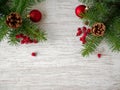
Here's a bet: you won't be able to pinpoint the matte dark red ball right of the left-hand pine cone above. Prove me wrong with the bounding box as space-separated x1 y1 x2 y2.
29 9 42 22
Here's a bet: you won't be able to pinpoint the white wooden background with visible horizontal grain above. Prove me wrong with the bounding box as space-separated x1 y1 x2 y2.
0 0 120 90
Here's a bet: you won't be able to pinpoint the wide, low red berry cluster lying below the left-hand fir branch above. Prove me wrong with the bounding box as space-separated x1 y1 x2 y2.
16 34 38 44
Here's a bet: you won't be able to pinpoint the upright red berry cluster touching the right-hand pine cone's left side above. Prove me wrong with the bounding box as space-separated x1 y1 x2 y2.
76 26 91 44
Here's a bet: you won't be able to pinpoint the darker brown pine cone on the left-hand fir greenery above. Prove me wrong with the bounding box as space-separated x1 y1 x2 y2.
6 12 22 28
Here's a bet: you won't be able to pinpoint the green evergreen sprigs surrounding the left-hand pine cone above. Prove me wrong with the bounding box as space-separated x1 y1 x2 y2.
0 0 46 45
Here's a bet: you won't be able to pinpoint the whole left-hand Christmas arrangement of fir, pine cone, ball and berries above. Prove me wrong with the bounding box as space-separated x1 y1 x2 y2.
0 0 46 45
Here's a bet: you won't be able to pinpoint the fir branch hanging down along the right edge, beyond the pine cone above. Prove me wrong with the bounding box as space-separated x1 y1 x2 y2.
106 17 120 51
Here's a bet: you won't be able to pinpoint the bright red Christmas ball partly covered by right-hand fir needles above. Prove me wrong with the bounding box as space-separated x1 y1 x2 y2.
75 5 86 18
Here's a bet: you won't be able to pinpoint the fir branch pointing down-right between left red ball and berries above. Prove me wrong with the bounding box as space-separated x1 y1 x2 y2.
20 19 46 41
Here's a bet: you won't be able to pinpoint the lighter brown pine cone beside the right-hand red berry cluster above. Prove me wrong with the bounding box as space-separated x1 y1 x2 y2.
91 23 106 36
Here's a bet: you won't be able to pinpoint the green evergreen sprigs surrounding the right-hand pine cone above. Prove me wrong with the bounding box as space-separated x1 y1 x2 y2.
79 0 120 56
